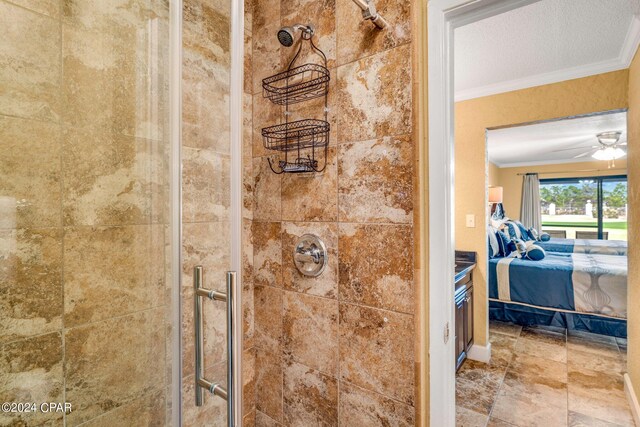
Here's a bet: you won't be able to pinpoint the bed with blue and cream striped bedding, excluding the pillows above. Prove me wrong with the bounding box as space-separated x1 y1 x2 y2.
489 252 627 337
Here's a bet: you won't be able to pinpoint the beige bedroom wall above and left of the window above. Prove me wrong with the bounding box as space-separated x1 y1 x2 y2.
498 159 627 219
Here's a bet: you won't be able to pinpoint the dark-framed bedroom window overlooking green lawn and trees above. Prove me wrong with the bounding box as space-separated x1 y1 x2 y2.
540 176 627 240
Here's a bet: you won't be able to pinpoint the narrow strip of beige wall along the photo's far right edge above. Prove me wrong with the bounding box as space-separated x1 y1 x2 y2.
627 46 640 412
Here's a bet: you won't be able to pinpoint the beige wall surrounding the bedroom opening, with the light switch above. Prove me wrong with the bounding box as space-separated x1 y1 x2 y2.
455 70 629 345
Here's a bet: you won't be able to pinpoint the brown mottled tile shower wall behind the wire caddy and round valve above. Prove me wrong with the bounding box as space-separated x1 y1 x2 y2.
245 0 416 426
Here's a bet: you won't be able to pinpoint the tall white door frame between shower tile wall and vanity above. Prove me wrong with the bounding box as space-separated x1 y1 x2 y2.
427 0 539 427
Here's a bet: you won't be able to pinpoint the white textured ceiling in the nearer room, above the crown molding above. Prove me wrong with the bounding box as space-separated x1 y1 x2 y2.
454 0 640 100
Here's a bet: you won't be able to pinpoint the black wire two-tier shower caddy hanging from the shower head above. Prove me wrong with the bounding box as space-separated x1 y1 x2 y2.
262 32 331 174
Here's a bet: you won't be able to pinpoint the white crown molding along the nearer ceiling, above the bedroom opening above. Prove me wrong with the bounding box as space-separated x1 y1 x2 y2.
455 15 640 102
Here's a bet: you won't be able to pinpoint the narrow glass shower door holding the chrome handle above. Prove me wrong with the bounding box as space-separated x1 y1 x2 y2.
181 0 243 426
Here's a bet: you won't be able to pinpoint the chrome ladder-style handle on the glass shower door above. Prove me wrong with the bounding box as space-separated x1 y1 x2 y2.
193 265 236 427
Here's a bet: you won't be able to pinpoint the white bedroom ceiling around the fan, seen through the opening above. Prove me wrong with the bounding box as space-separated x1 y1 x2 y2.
487 112 627 167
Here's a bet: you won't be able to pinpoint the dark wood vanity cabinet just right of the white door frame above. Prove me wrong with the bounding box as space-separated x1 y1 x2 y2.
455 271 473 370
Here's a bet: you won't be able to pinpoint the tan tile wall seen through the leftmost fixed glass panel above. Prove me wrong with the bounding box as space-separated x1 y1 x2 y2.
0 0 170 426
